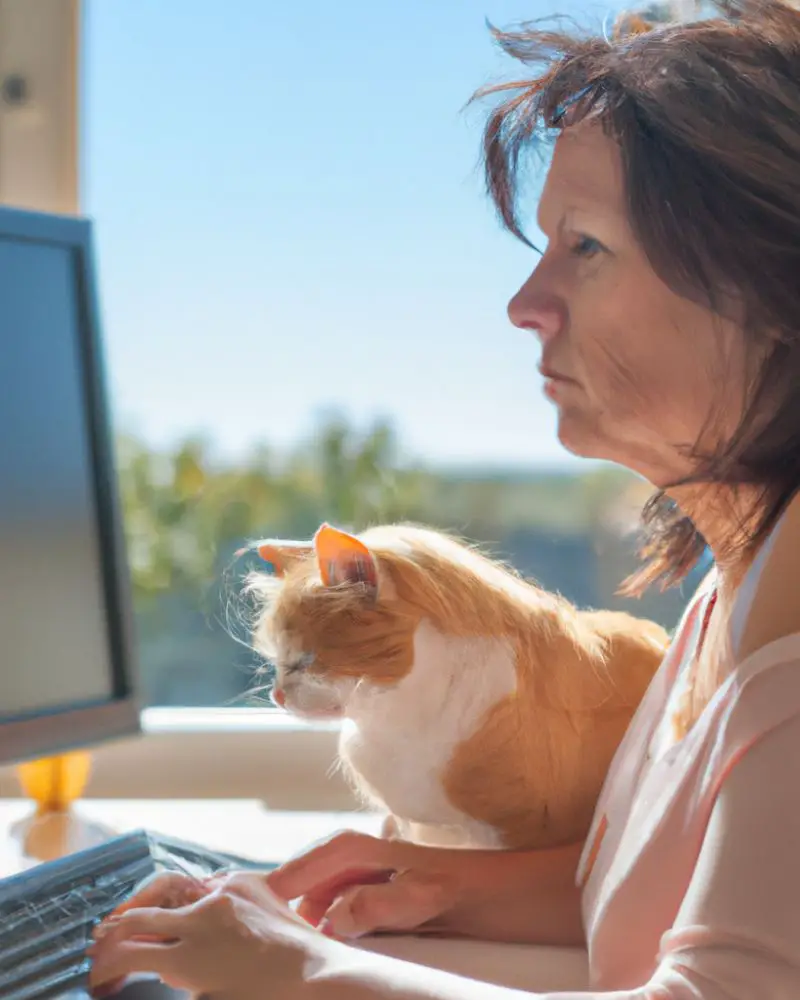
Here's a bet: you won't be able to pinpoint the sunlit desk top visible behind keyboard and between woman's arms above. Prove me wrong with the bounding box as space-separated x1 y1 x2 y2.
0 799 588 991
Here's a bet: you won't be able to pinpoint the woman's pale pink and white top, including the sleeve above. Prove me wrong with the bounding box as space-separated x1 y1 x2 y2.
558 500 800 1000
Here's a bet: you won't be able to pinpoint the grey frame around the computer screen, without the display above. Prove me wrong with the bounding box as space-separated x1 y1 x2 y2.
0 206 141 765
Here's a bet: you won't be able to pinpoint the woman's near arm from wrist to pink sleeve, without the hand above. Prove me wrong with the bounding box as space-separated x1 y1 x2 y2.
314 712 800 1000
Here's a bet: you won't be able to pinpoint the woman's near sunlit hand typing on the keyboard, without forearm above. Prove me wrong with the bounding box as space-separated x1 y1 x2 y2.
89 873 328 1000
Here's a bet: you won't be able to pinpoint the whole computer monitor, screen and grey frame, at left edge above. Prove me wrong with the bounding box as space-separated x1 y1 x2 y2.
0 208 139 763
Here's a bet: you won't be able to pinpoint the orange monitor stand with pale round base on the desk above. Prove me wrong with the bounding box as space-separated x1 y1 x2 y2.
9 751 117 862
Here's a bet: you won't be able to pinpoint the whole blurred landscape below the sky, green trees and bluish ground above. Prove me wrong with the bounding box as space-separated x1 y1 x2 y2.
112 416 700 705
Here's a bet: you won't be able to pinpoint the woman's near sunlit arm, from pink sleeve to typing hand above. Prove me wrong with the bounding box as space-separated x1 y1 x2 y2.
91 712 800 1000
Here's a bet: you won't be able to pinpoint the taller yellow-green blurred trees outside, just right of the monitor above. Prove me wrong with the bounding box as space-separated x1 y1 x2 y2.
117 419 422 598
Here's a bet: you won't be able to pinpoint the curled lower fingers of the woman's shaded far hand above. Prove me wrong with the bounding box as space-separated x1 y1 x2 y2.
319 872 453 940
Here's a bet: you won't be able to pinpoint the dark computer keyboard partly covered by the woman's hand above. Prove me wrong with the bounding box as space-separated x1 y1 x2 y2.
0 830 275 1000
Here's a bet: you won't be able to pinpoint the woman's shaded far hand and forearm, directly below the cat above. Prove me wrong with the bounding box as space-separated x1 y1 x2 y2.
266 832 585 945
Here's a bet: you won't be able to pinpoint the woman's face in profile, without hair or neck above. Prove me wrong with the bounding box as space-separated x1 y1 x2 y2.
509 122 746 485
